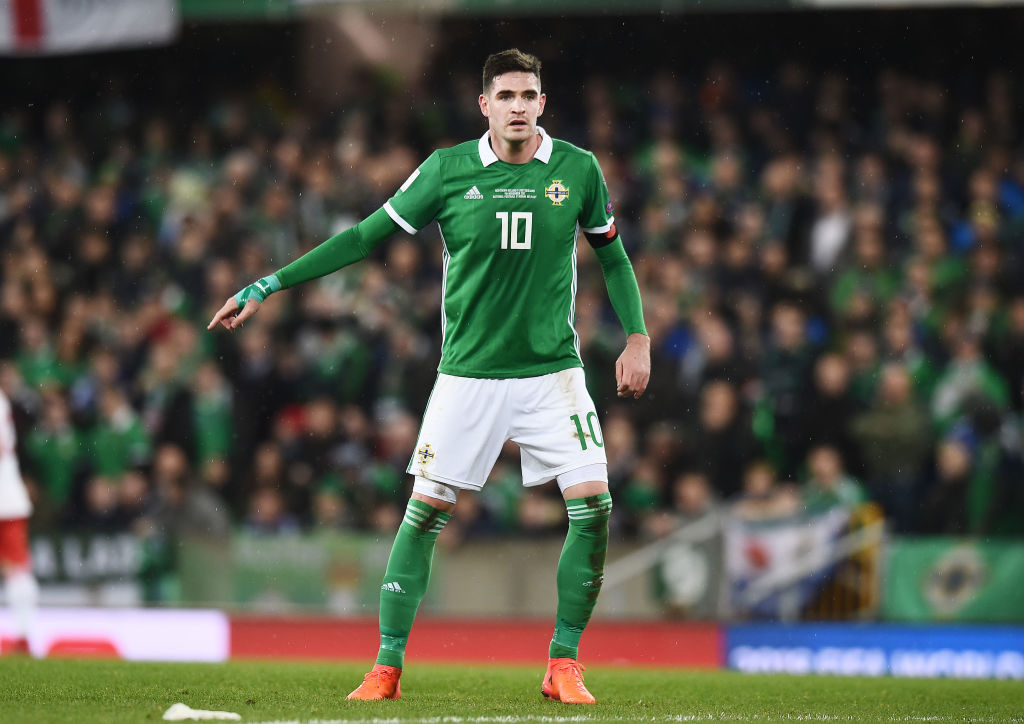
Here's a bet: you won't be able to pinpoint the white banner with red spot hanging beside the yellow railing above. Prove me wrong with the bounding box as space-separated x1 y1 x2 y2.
725 508 850 619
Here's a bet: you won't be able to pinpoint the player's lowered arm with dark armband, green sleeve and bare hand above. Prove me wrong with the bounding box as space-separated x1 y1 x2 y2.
587 235 650 398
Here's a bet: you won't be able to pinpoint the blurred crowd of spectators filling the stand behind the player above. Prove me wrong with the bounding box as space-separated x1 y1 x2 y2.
0 52 1024 548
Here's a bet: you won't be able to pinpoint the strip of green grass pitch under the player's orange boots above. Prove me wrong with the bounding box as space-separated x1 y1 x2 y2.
0 658 1024 724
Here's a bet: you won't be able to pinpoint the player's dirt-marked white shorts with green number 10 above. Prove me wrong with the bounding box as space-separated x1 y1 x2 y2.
409 368 608 491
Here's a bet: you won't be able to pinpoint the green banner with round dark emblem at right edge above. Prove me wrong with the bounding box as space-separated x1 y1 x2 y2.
882 538 1024 622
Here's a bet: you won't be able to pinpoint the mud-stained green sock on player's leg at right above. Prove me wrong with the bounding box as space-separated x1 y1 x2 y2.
548 493 611 658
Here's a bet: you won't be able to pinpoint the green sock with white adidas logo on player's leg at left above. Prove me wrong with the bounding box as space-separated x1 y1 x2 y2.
377 500 452 669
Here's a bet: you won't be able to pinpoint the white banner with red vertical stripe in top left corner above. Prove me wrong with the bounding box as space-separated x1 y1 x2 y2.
0 0 179 55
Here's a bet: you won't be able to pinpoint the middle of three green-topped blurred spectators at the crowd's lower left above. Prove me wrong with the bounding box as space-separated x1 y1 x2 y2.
89 387 152 477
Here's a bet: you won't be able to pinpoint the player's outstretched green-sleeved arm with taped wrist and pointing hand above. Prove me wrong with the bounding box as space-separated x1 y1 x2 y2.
207 209 398 332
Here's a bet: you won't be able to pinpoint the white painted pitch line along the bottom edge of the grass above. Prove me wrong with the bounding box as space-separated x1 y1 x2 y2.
241 712 1024 724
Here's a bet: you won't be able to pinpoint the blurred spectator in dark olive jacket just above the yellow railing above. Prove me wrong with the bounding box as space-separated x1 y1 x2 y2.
851 363 932 533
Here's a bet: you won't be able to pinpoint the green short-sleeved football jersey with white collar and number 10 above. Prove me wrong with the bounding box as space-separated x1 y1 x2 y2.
384 128 613 378
